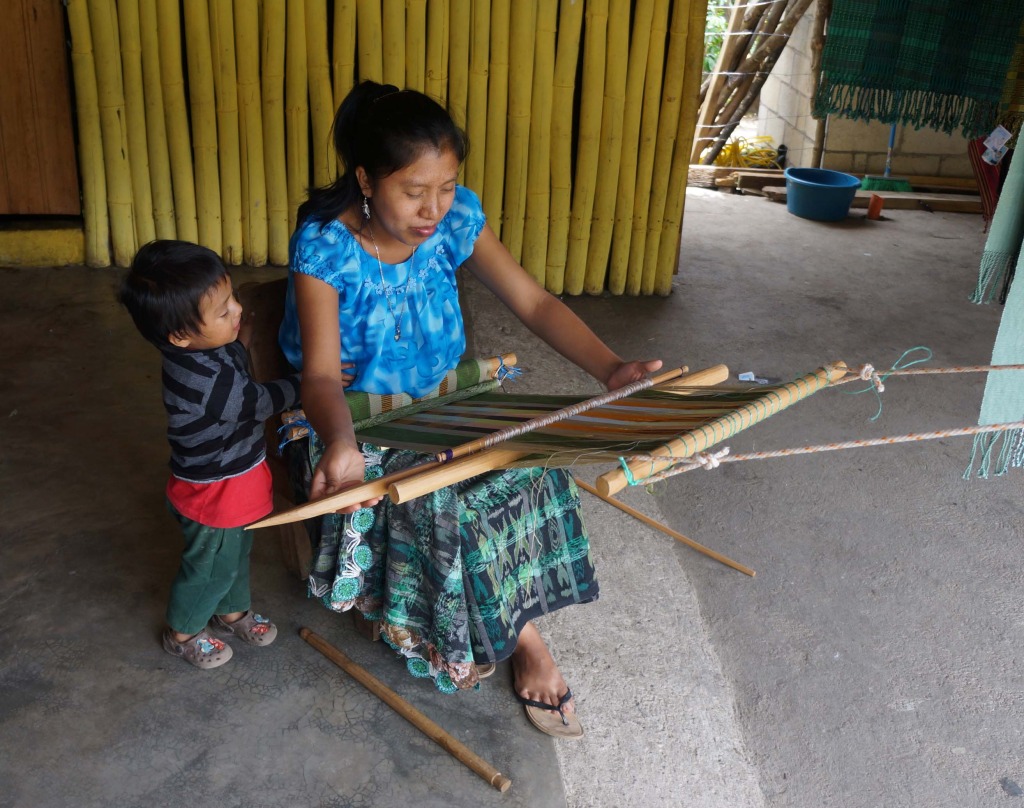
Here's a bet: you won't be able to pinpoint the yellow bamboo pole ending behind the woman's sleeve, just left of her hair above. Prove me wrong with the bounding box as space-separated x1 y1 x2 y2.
285 0 309 230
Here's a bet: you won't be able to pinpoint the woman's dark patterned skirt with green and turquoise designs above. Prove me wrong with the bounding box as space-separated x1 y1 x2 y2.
289 434 598 692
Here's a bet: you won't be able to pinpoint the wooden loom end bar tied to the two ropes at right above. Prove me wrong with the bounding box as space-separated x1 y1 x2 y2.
597 363 847 497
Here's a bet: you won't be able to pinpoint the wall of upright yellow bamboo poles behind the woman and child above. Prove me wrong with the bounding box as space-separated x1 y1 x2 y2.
67 0 707 295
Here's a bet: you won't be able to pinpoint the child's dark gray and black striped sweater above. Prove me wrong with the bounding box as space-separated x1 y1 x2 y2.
163 341 299 482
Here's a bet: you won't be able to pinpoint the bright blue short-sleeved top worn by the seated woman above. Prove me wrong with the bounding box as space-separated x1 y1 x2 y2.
279 185 486 396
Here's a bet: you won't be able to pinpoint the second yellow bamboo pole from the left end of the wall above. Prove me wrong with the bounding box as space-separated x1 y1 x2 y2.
89 0 137 266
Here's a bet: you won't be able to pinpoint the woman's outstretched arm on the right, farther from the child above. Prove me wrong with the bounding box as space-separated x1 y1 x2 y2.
466 224 662 390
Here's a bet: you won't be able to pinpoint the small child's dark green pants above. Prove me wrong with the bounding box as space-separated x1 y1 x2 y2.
167 503 253 634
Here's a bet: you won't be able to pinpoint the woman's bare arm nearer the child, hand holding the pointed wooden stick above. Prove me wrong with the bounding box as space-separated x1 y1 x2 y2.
294 273 380 513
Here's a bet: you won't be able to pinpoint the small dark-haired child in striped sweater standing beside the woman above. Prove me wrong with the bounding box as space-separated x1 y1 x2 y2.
119 241 299 668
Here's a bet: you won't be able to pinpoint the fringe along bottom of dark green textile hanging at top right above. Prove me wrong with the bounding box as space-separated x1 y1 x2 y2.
814 83 999 137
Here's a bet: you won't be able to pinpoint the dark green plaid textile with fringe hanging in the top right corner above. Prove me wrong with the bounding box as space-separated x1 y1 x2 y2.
814 0 1024 137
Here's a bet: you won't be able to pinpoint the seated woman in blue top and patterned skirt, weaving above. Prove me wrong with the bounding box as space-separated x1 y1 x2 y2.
281 82 662 736
